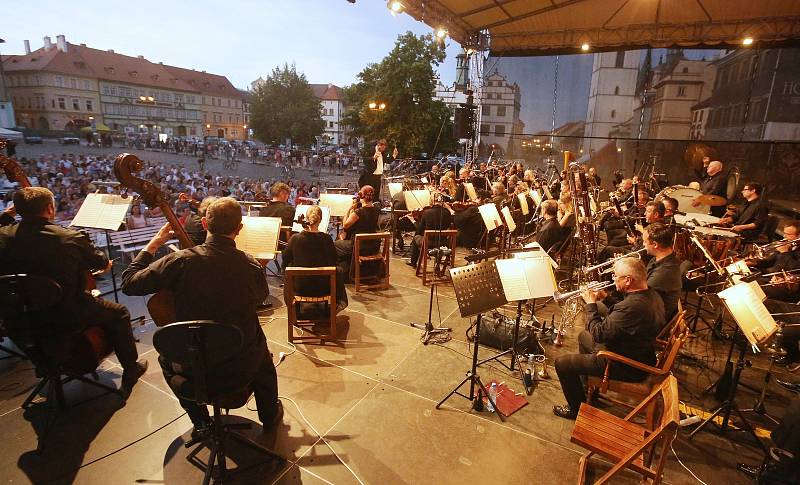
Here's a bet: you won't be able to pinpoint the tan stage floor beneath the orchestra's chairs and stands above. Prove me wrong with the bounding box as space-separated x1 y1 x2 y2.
0 248 797 484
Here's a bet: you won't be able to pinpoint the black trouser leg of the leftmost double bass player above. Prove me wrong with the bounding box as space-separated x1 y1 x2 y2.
70 298 139 369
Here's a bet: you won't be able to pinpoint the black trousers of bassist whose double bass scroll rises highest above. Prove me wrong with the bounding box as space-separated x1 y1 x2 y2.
158 356 278 427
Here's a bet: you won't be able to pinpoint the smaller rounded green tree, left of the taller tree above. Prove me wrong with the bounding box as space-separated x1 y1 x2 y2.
250 64 325 145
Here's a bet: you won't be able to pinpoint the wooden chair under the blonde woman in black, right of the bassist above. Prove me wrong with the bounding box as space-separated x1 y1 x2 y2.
283 266 336 343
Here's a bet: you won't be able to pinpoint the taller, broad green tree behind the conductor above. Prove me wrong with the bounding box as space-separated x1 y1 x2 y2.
343 32 457 157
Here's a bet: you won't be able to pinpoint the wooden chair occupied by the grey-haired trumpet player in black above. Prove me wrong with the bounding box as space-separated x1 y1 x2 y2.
587 313 689 407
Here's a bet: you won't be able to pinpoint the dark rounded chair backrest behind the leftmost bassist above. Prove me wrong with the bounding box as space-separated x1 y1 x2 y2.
0 274 61 318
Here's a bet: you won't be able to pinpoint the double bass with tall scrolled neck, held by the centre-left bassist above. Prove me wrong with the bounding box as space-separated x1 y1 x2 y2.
114 153 194 327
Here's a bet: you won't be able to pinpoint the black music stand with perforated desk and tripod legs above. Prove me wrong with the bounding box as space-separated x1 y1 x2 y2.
436 261 506 421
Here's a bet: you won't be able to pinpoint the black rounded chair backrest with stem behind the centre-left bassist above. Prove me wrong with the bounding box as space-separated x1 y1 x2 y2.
153 320 242 403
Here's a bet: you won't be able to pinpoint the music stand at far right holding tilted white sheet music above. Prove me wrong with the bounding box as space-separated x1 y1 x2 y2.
689 282 778 452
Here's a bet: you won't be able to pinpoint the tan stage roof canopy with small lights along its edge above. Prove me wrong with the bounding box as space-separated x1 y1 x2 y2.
398 0 800 56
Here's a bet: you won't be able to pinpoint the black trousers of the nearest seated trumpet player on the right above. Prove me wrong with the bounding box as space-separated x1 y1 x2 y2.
554 330 644 413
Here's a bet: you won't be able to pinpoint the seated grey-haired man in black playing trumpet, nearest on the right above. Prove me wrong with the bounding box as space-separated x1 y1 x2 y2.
553 258 664 419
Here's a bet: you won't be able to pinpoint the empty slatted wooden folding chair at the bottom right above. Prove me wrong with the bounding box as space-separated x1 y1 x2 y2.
570 376 680 484
